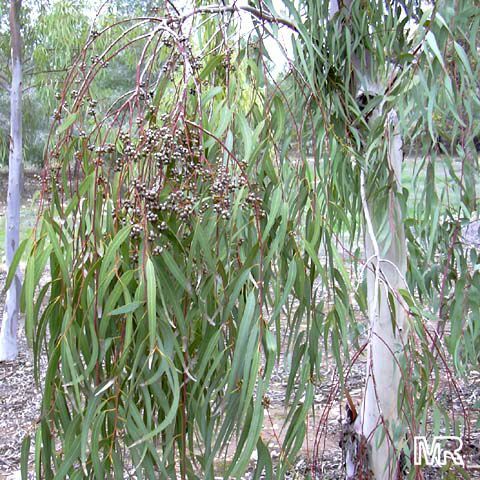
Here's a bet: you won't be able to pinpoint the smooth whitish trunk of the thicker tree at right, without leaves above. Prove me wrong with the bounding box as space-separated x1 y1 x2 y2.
357 112 407 480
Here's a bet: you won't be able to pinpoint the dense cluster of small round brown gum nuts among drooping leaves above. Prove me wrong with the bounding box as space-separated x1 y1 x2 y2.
109 125 261 261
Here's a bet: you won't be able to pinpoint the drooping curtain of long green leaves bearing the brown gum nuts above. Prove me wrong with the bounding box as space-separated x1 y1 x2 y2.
15 5 304 478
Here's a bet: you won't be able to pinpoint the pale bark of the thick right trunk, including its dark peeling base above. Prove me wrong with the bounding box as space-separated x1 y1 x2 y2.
328 0 407 480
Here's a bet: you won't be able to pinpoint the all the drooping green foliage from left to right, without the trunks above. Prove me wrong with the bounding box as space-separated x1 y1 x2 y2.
13 0 480 479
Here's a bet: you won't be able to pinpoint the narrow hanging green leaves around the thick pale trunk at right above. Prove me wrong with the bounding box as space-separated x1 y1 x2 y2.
271 1 480 478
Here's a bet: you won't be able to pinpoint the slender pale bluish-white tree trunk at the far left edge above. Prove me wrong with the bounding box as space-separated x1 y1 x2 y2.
0 0 23 361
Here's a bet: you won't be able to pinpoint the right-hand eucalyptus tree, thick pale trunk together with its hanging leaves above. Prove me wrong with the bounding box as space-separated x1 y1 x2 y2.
269 1 479 479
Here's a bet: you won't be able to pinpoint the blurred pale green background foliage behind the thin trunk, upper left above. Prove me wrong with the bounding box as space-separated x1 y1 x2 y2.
0 0 160 168
